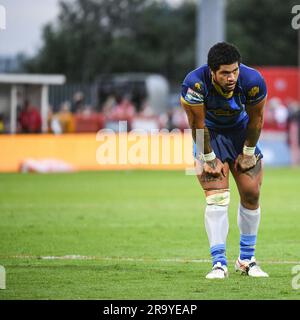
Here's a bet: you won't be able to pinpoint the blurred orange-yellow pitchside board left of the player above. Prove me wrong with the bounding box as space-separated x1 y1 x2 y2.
0 133 193 172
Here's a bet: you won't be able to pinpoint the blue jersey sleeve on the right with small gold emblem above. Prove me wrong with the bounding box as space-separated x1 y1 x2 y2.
246 70 267 106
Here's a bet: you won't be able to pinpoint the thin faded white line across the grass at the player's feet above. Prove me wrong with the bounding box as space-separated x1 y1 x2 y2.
0 255 300 265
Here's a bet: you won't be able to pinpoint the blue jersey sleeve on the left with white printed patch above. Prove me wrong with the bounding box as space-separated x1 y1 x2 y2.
181 75 204 106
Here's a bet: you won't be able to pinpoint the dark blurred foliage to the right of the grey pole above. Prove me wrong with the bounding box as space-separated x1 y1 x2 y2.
226 0 299 66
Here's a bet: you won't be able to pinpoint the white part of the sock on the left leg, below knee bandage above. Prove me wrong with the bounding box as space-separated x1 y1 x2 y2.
205 205 229 247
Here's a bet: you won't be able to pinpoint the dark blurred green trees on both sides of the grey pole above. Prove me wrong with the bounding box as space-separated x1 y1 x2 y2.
24 0 297 83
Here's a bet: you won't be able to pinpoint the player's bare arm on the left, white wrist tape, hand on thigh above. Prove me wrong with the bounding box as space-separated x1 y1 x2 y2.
180 97 225 177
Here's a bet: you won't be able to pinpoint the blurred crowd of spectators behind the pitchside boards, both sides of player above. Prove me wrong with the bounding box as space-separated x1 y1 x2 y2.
0 92 300 141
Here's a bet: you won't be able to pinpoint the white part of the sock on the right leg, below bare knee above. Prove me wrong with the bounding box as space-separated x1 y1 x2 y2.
238 204 260 235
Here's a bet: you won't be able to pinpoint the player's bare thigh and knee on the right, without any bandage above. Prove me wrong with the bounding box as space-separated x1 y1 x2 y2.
230 160 263 205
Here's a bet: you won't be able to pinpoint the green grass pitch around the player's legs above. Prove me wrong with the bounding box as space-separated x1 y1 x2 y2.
0 168 300 300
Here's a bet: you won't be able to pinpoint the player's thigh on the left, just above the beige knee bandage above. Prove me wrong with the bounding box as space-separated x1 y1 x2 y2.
195 160 229 196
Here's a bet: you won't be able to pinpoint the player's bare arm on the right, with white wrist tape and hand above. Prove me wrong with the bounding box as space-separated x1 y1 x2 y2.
237 98 266 172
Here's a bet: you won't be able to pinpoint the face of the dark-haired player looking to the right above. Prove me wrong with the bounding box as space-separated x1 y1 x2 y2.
212 62 240 91
